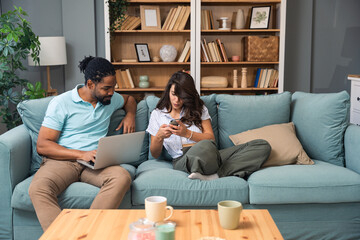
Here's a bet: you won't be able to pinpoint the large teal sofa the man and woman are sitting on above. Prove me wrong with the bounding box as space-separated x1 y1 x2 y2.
0 91 360 240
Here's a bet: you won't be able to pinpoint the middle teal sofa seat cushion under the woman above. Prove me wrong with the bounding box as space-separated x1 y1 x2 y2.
131 160 249 207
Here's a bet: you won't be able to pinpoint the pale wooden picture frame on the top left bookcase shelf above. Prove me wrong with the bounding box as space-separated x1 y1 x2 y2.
140 5 161 30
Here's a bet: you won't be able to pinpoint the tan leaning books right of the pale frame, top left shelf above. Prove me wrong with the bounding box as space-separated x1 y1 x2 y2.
162 6 190 30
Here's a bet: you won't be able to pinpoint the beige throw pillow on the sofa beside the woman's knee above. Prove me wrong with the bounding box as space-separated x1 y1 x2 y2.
229 122 314 167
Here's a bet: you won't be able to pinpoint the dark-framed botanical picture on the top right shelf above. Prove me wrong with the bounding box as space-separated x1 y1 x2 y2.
250 6 271 29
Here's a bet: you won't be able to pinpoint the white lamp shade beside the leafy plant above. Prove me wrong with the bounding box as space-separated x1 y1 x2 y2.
28 37 67 66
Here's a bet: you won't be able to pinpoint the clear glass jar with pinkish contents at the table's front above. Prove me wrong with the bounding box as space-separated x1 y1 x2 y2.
128 218 155 240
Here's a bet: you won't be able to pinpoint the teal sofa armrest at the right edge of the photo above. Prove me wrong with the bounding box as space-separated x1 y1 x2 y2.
344 124 360 174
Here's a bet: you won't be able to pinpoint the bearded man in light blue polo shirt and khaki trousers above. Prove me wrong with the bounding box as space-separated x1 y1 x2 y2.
29 57 136 231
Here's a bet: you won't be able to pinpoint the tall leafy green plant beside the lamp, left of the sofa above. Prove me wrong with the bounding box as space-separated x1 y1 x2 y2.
0 6 45 129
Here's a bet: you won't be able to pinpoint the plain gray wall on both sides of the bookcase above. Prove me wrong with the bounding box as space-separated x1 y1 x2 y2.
0 0 360 133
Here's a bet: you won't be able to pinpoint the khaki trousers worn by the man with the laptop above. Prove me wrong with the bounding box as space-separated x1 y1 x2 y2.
29 158 131 231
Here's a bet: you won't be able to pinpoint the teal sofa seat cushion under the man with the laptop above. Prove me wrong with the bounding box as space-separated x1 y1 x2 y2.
11 164 135 211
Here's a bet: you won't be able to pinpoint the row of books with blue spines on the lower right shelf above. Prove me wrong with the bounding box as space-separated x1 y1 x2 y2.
254 68 279 88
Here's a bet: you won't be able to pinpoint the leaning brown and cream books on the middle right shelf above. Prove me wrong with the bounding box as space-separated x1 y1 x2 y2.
201 38 229 62
